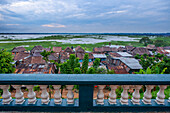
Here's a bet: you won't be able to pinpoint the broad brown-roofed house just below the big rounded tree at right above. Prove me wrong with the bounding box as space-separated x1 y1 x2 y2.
131 47 150 56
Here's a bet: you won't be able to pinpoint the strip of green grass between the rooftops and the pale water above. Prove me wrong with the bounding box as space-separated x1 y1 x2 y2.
0 41 143 51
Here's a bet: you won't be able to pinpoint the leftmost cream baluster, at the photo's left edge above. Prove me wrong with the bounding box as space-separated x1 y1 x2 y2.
1 85 12 104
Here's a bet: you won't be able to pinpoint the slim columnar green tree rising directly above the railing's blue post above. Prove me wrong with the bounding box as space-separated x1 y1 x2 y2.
81 53 89 73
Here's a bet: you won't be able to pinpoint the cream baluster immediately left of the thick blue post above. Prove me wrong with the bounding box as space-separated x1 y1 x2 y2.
66 85 74 104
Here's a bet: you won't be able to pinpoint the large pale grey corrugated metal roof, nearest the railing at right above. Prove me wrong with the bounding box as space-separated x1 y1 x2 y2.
119 57 142 69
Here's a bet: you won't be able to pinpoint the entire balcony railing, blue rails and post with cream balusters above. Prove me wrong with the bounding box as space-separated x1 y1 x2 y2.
0 74 170 112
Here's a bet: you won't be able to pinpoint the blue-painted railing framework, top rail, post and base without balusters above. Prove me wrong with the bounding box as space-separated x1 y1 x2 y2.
0 74 170 112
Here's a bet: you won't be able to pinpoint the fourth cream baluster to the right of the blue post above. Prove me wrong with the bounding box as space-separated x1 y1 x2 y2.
132 85 142 104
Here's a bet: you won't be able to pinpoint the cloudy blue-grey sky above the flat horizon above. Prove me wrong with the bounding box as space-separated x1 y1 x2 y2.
0 0 170 33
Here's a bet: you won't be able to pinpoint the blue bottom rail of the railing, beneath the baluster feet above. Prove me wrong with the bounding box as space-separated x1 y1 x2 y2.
0 99 170 112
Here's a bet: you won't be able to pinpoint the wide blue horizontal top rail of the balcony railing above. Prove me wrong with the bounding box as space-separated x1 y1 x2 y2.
0 74 170 85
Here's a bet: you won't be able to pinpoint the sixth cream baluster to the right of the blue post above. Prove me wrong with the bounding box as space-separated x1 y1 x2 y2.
155 85 167 104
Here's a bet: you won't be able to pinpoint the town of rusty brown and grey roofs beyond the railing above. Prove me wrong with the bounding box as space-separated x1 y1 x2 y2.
11 44 170 74
